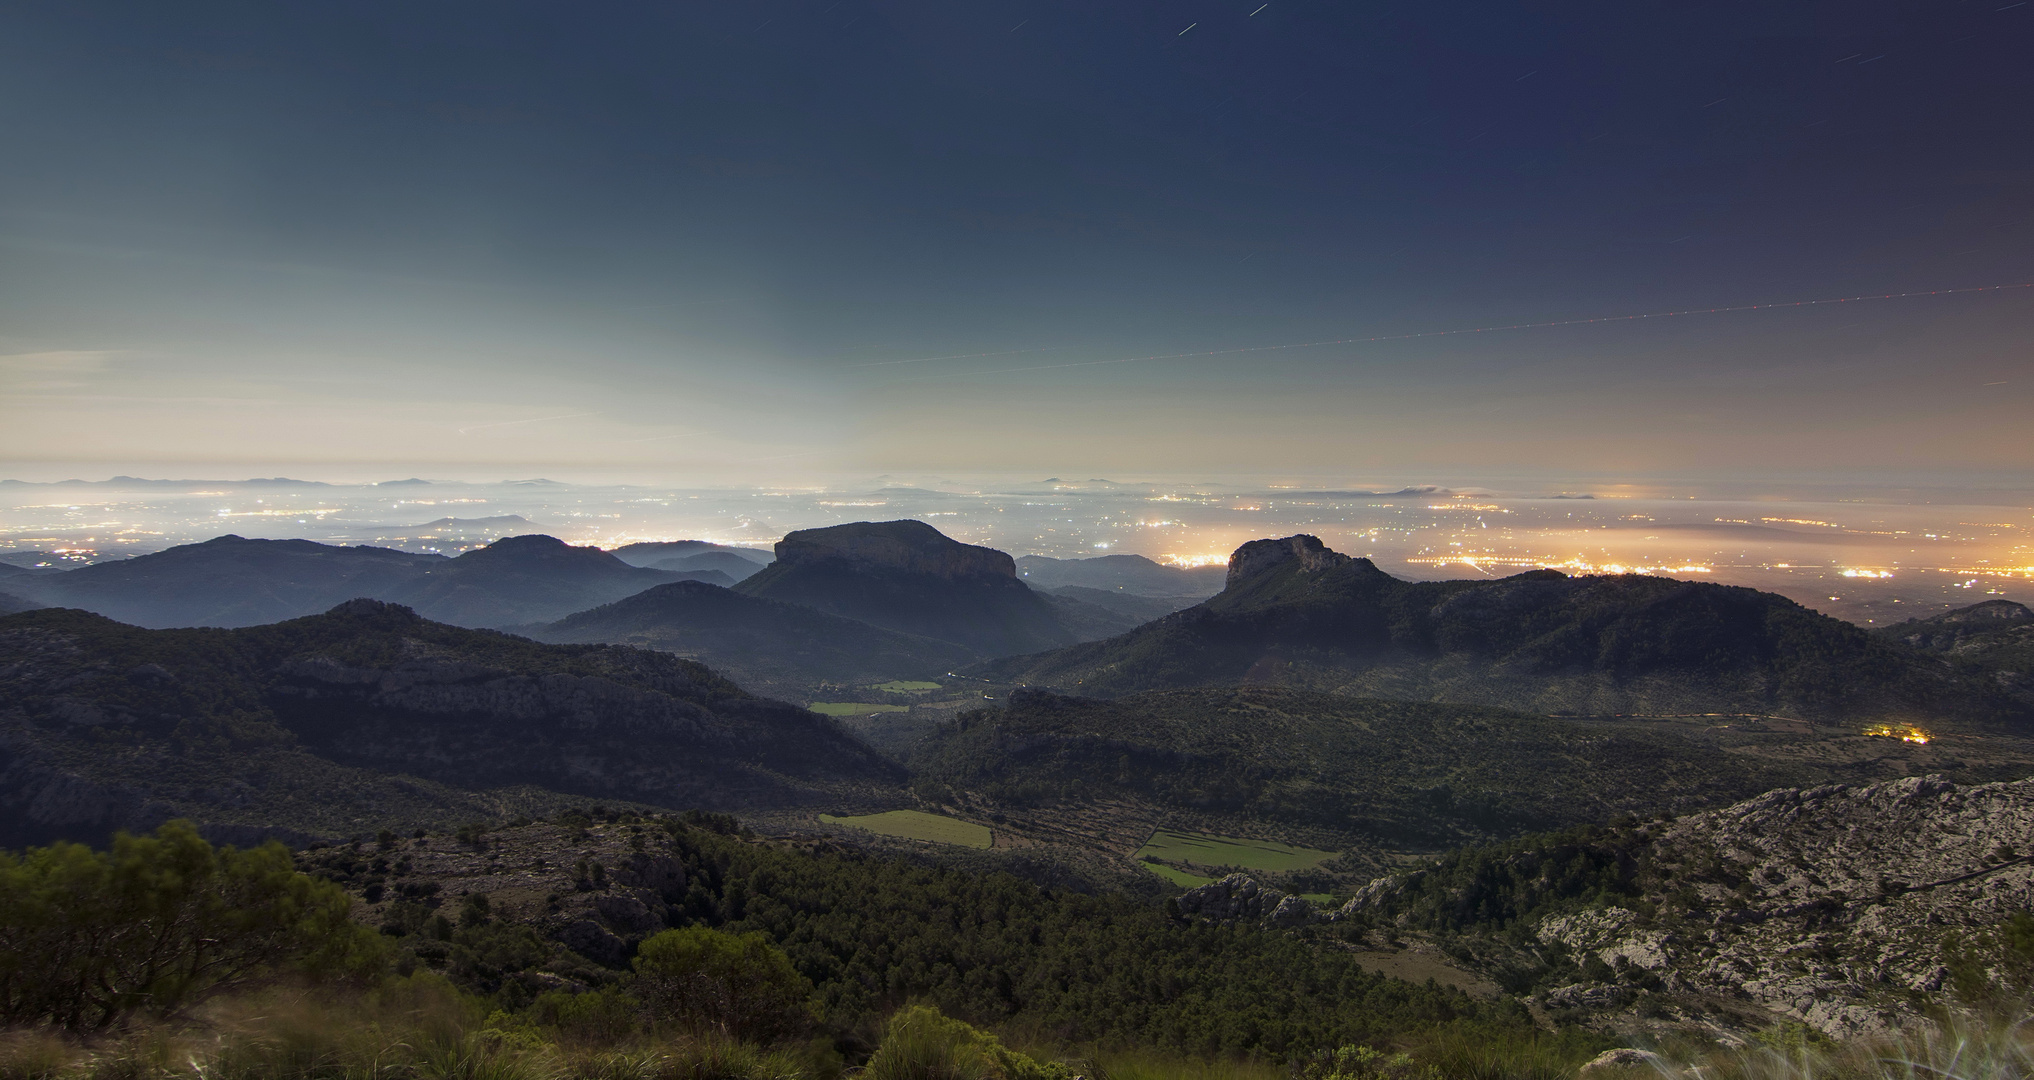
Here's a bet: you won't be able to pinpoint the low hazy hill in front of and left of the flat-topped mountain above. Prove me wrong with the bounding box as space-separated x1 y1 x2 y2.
531 582 974 694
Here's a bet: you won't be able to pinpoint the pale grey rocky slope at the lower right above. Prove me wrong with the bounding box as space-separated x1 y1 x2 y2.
1340 777 2034 1037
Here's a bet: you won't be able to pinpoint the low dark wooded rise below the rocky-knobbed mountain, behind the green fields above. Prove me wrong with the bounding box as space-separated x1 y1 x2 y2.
911 687 2026 850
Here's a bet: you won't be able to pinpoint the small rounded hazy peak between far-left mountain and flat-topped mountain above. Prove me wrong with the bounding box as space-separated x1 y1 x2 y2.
388 537 677 626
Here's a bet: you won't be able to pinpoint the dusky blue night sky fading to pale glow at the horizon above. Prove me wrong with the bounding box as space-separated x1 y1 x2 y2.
0 0 2034 482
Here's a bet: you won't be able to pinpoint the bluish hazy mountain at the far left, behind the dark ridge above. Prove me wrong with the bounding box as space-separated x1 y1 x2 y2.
8 535 439 626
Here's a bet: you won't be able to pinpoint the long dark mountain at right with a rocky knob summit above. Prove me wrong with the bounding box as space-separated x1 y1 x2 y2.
976 535 2028 722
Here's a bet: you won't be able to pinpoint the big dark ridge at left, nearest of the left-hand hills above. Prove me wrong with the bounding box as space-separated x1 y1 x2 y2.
0 600 901 846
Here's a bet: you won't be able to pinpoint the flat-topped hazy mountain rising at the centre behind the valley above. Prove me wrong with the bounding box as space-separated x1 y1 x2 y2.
734 521 1074 657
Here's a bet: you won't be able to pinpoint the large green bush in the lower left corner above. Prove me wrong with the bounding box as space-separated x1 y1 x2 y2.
0 822 382 1029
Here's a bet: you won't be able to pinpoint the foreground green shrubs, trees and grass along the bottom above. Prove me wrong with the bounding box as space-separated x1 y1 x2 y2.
15 814 2034 1080
